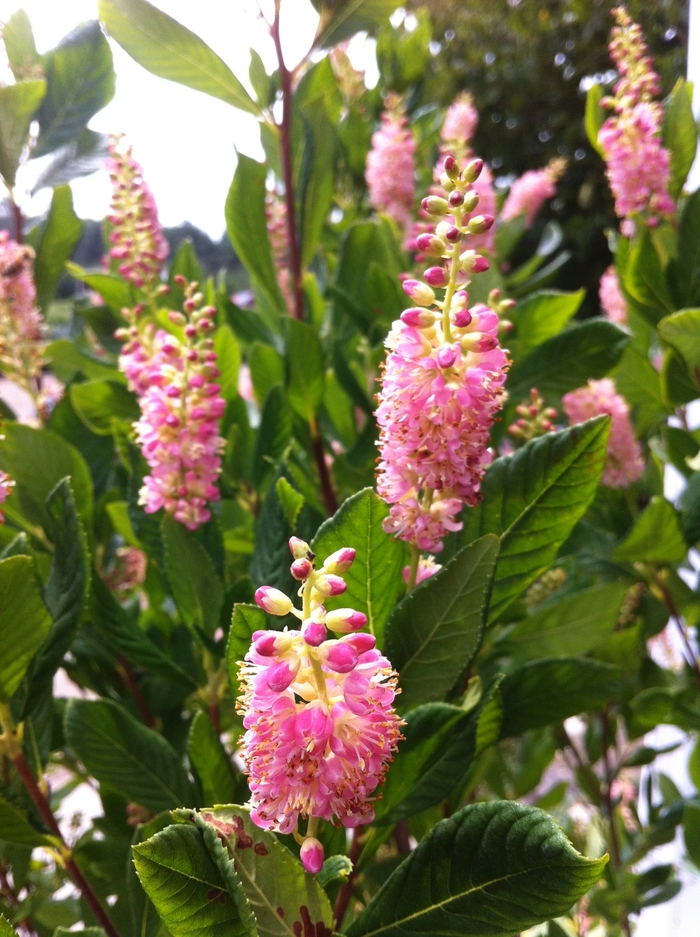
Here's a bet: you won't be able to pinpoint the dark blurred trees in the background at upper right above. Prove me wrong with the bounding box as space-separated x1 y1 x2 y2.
400 0 688 314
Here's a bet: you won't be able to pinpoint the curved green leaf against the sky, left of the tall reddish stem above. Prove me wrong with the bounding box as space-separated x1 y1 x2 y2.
226 153 285 311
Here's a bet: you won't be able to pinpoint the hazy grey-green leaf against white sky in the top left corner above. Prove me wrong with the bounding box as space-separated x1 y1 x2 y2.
32 20 115 157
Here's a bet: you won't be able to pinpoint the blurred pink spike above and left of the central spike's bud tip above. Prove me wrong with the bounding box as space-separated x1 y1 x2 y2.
365 96 416 229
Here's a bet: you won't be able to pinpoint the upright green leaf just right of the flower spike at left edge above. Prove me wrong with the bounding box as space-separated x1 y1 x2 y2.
34 185 83 310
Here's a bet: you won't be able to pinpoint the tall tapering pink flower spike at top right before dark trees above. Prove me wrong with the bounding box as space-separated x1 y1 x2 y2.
598 7 675 234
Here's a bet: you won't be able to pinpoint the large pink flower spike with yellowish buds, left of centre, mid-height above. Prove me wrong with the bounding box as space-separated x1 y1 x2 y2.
117 277 226 530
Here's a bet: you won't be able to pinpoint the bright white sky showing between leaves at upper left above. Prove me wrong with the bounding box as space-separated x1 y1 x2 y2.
0 0 328 238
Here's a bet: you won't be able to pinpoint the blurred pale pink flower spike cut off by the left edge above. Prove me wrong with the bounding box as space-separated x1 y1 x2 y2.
0 231 46 399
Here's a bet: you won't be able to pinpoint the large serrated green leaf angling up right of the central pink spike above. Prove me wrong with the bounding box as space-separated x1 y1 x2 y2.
461 417 609 621
